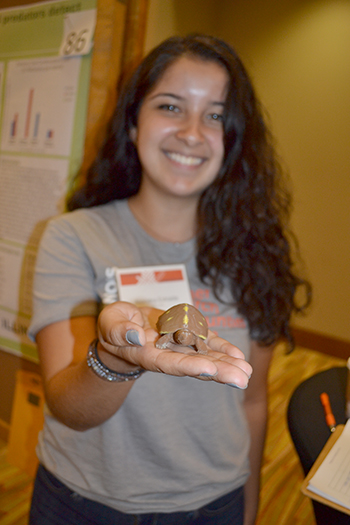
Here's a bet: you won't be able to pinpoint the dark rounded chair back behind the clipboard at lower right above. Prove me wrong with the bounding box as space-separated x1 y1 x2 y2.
287 367 350 525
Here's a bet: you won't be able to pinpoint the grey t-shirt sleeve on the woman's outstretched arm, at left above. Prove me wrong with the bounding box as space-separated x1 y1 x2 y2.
28 216 99 340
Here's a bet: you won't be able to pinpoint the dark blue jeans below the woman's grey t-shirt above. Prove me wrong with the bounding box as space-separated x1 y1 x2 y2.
29 465 244 525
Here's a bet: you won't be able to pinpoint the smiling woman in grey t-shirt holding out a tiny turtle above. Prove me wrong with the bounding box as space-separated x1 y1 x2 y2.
30 35 307 525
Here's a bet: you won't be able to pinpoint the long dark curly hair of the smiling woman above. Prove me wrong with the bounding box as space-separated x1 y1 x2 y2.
67 34 310 345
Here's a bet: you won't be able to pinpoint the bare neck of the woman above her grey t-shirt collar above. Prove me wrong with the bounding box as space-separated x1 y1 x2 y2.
128 194 197 243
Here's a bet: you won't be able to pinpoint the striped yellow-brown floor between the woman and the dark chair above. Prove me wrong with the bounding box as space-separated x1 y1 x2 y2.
257 346 346 525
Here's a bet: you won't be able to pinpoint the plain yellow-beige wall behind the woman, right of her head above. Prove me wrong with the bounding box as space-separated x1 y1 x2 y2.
146 0 350 341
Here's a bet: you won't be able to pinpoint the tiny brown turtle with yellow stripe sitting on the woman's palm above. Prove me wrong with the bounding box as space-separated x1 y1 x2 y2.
156 303 209 354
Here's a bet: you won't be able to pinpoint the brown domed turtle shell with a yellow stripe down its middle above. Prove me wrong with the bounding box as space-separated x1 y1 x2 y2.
157 303 208 340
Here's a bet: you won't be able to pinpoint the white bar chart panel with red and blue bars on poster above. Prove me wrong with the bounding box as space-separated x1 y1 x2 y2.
1 57 81 156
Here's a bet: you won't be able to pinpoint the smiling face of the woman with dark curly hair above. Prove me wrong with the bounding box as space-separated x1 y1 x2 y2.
131 57 228 198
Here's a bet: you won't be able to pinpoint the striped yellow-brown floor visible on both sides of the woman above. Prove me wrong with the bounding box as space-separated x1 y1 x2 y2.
0 346 345 525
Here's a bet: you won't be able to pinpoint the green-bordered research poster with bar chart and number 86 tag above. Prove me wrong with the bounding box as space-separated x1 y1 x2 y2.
0 0 96 361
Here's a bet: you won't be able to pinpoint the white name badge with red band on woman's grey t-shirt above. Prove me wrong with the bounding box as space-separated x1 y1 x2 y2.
116 264 192 310
